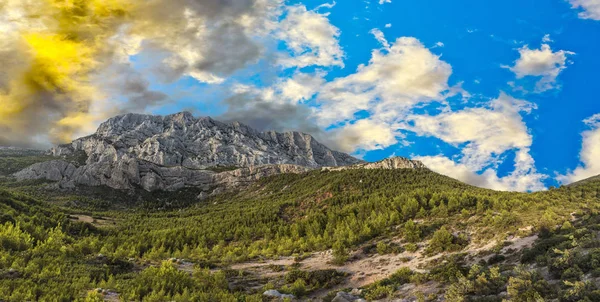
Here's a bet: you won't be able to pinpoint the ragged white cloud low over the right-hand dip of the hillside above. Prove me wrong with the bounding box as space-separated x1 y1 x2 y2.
407 93 546 191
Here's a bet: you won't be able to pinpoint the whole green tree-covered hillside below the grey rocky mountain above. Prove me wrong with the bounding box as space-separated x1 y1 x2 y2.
0 169 600 301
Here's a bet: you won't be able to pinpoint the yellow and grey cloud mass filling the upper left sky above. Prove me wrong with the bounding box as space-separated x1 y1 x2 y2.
0 0 281 145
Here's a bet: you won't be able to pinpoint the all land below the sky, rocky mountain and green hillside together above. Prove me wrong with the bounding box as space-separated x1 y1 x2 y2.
0 113 600 302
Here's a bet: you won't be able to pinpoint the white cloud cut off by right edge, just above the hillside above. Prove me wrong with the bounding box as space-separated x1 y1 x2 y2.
558 114 600 183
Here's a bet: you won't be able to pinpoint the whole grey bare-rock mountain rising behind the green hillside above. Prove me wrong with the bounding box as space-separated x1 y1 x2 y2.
15 113 362 191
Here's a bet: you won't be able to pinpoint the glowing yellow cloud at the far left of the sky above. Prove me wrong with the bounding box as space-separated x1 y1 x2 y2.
0 0 135 143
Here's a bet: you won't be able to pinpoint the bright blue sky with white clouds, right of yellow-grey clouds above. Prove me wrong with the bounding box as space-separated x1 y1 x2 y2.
125 0 600 191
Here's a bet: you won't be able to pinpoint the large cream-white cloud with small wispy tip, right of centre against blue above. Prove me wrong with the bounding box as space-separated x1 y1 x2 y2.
318 30 452 126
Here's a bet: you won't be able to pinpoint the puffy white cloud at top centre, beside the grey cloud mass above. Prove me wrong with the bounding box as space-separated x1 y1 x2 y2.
276 5 344 67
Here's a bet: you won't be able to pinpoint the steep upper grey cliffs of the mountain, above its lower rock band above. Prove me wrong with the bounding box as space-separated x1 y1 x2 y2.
52 112 362 169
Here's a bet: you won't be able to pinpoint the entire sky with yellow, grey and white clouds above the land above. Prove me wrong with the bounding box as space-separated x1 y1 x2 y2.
0 0 600 191
